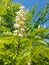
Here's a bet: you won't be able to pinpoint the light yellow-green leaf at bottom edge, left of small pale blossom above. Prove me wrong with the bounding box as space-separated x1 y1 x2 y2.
16 51 31 65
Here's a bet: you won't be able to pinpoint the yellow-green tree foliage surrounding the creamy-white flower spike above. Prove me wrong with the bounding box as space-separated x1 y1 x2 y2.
0 0 49 65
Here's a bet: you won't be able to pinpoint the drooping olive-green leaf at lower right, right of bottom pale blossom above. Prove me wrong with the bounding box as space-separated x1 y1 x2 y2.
31 46 42 63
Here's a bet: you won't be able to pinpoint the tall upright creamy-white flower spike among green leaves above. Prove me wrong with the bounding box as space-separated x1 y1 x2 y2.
14 6 26 36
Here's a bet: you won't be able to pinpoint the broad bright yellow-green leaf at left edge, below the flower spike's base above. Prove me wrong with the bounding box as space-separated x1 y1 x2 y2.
0 34 17 44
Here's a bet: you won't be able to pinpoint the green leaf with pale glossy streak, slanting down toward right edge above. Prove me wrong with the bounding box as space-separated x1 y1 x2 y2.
32 35 48 46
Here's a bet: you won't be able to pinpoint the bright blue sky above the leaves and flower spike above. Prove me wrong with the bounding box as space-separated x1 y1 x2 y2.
13 0 49 26
